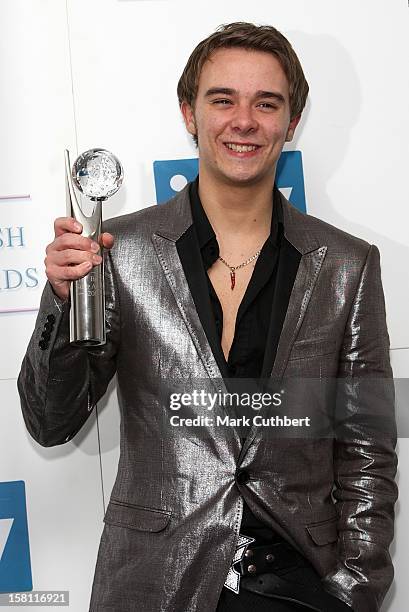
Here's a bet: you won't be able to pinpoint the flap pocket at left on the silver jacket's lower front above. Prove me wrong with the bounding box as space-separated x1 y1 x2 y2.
104 499 172 532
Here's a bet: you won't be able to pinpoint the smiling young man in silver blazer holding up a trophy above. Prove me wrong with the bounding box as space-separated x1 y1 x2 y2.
19 23 396 612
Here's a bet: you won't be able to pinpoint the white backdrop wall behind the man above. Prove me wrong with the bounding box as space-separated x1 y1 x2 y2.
0 0 409 612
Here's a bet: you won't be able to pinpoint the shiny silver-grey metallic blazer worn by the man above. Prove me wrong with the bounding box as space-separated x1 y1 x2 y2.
18 187 397 612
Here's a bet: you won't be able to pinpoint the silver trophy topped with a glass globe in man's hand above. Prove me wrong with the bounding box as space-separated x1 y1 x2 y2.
65 149 123 346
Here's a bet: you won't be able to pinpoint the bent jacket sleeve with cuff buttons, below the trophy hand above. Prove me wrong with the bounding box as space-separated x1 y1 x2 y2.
17 252 120 446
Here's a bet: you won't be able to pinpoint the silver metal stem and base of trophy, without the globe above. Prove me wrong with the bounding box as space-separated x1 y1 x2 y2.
65 151 106 346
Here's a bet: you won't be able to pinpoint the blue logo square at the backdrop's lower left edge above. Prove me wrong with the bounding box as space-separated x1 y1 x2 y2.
0 480 33 593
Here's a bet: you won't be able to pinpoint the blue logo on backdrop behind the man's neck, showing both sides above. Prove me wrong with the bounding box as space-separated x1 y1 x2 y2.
153 151 306 212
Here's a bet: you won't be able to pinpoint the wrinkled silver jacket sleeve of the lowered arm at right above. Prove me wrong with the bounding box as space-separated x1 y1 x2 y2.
323 245 397 612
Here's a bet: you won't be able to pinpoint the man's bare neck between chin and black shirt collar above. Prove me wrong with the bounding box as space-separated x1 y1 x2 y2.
199 172 274 239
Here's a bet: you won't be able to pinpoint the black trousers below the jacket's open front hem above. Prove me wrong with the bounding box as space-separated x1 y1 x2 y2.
216 561 353 612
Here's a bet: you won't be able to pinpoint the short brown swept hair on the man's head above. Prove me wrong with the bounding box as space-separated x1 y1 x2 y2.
177 21 309 119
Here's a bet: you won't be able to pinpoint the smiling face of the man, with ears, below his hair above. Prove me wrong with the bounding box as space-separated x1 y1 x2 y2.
181 48 300 186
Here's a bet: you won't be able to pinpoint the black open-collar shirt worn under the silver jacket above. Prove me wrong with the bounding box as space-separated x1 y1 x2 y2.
176 173 301 378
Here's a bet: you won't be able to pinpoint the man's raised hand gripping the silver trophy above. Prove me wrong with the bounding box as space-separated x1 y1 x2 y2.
44 217 114 300
